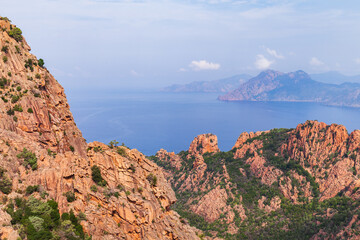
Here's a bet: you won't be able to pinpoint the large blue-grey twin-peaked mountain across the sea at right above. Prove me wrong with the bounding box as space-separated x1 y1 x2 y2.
218 70 360 107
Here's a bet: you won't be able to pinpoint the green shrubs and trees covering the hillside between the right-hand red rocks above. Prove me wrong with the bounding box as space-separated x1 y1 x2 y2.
151 126 360 239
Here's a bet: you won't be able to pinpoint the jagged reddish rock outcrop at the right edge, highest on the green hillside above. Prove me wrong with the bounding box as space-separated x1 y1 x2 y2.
282 121 360 200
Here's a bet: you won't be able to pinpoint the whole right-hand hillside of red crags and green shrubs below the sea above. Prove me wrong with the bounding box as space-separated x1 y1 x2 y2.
152 121 360 239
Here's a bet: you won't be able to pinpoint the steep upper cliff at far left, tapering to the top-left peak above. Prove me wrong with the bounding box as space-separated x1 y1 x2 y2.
0 20 86 157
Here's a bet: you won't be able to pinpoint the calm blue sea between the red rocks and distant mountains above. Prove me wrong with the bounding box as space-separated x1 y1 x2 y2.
67 91 360 155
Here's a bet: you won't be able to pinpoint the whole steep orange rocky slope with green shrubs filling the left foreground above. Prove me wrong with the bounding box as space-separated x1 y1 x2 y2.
0 18 198 240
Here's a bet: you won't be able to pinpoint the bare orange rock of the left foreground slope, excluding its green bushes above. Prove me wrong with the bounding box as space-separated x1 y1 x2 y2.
0 20 199 240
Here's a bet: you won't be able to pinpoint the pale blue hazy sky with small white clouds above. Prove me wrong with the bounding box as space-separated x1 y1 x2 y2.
0 0 360 89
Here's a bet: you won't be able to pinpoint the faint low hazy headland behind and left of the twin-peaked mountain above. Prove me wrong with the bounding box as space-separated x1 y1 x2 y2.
161 74 252 93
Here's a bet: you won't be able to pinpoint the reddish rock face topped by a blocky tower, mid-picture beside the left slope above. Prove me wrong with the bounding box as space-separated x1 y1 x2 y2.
152 134 246 237
